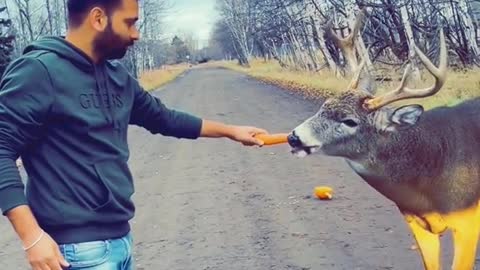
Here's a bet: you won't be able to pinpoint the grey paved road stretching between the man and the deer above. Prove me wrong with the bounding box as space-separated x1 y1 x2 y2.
0 68 464 270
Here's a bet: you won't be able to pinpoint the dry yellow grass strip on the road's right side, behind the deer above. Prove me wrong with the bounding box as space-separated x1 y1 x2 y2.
215 59 480 109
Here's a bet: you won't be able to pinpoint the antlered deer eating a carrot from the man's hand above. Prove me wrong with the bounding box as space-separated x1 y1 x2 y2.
288 10 480 270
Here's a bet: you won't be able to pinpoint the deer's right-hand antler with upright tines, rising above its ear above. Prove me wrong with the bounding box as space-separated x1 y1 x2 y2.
365 29 448 110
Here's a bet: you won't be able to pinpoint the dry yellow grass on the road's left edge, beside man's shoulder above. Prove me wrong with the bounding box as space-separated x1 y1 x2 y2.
139 64 189 91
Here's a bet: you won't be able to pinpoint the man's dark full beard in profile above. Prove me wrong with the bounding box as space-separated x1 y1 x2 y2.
93 23 133 60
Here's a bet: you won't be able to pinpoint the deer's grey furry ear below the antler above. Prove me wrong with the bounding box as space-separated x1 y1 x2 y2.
375 105 424 132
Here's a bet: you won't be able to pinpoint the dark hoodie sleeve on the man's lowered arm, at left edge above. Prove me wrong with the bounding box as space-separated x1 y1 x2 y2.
0 57 54 215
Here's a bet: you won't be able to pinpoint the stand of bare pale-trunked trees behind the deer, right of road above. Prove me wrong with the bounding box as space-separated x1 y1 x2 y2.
212 0 480 74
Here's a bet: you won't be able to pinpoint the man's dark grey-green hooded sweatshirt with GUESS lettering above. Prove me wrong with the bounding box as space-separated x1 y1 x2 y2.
0 37 202 244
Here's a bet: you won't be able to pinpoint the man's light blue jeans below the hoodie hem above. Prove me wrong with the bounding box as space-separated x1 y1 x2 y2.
59 234 134 270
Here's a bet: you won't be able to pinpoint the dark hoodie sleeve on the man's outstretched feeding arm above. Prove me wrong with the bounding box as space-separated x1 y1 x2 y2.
130 80 202 139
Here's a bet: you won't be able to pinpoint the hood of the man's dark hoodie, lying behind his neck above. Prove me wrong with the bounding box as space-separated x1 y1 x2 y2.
23 36 95 71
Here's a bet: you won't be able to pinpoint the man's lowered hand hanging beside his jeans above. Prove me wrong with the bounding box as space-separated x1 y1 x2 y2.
27 233 69 270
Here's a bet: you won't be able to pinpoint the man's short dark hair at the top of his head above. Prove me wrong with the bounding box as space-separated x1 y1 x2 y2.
67 0 122 27
